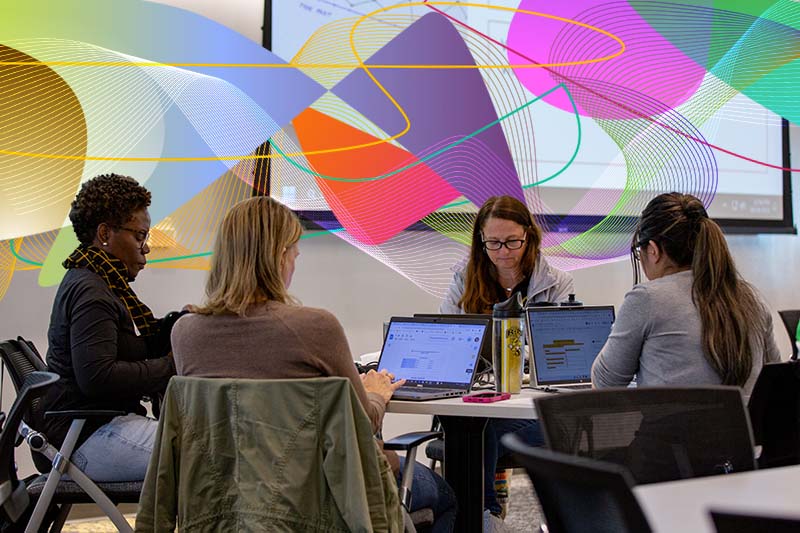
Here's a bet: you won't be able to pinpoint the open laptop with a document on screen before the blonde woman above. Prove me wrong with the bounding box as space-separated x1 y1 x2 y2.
378 317 491 400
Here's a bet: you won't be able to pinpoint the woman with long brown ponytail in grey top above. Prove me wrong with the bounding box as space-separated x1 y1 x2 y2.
592 192 780 398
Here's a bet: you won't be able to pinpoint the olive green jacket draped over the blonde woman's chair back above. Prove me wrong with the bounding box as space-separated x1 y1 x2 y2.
136 376 403 532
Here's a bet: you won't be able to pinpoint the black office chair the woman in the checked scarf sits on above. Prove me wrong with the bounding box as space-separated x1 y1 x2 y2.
0 337 143 532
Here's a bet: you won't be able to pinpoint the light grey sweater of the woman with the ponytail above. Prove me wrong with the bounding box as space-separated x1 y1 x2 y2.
592 271 780 398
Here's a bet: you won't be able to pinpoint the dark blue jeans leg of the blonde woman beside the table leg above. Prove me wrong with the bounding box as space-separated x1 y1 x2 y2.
397 457 457 533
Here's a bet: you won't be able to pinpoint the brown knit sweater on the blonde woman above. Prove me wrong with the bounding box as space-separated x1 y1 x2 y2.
172 302 386 431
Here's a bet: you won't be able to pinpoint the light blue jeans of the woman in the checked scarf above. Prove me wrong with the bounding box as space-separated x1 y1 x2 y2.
72 414 158 482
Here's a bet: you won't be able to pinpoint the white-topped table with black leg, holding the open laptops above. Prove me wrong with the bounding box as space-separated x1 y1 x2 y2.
386 389 552 532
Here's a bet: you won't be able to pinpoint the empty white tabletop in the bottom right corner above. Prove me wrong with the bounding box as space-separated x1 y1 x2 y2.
633 466 800 533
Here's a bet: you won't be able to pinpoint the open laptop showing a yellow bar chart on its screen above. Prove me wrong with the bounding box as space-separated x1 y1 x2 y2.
525 305 614 390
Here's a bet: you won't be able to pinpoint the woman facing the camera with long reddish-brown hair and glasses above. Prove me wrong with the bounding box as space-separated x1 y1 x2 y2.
439 196 574 314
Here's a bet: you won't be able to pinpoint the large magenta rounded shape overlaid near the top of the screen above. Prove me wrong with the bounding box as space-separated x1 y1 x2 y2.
507 0 710 119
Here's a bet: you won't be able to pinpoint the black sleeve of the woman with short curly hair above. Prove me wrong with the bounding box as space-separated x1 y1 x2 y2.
70 286 175 398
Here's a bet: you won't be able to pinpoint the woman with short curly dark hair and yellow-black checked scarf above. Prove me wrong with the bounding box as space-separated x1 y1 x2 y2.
41 174 175 481
